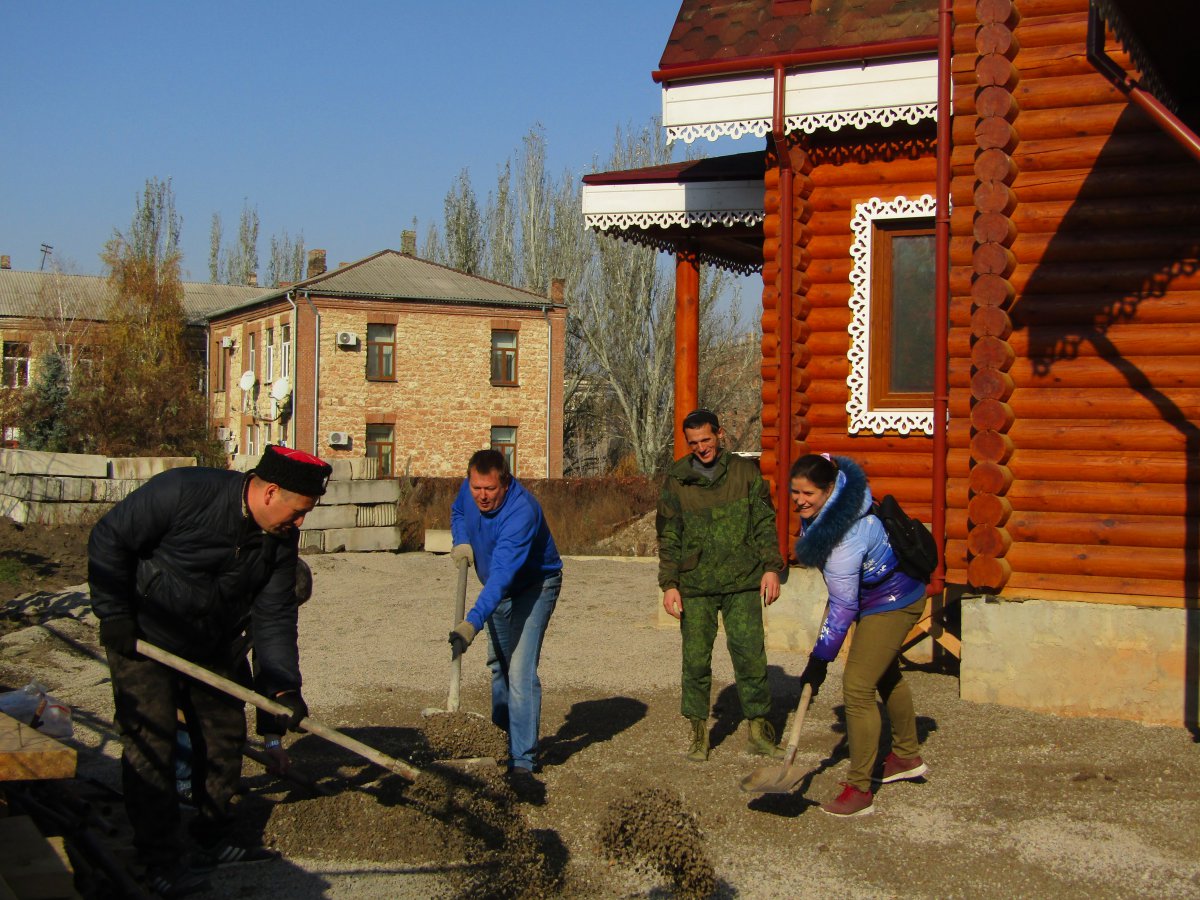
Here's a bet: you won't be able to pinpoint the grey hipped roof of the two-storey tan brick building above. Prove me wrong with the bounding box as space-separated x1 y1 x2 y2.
210 250 562 318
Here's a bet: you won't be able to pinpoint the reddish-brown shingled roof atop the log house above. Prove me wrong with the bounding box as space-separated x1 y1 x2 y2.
659 0 937 73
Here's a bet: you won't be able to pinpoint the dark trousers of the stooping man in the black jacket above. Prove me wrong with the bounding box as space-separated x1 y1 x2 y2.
108 650 250 865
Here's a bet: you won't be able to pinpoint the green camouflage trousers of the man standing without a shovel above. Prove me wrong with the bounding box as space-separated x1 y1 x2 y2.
679 590 770 719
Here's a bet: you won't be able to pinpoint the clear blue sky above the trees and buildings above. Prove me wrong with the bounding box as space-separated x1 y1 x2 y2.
0 0 679 281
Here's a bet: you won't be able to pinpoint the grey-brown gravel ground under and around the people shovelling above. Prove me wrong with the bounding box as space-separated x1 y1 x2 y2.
0 553 1200 900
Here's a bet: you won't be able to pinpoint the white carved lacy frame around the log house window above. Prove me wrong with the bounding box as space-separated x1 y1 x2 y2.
846 193 937 434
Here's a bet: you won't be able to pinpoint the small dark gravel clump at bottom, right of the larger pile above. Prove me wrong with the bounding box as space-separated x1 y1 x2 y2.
599 787 716 900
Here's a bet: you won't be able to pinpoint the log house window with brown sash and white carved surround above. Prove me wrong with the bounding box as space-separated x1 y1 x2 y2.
846 194 935 434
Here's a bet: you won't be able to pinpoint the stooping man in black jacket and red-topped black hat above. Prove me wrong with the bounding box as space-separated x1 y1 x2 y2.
88 446 331 896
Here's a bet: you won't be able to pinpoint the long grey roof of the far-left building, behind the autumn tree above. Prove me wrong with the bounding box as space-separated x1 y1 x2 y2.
0 269 265 323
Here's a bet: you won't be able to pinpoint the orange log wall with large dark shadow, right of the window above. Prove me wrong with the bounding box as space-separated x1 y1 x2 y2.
955 0 1200 607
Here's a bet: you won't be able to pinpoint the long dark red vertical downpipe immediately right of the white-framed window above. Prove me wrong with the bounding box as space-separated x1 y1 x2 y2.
929 0 954 595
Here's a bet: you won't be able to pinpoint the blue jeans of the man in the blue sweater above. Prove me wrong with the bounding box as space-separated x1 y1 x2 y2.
487 572 563 770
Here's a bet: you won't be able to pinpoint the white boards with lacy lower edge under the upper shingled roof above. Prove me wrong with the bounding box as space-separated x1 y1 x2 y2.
662 58 937 144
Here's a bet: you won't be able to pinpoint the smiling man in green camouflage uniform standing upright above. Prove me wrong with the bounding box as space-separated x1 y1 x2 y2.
658 409 784 762
